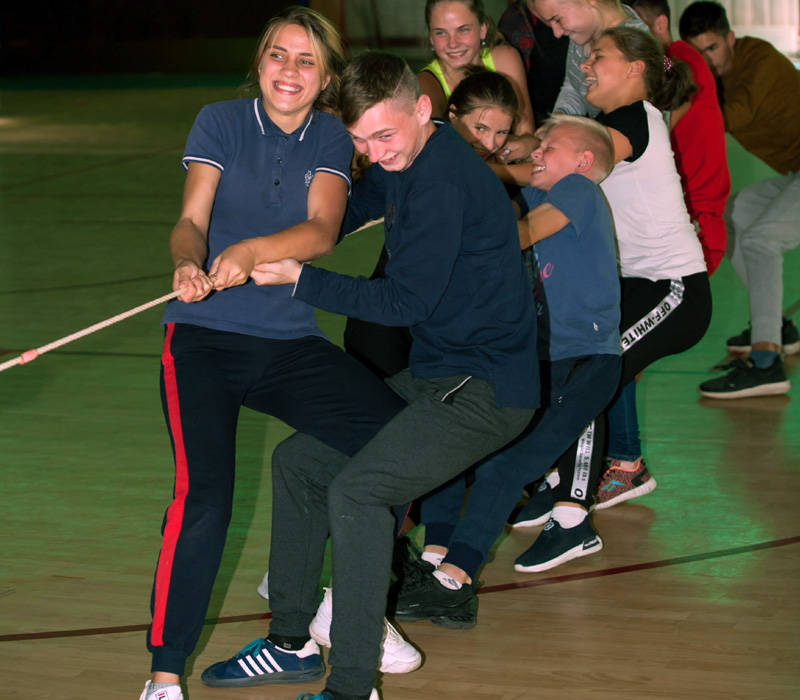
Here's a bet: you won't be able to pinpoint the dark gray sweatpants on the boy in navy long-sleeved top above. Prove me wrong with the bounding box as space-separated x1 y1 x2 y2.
269 370 533 694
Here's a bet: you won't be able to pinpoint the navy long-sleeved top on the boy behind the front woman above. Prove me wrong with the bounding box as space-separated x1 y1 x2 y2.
295 124 539 408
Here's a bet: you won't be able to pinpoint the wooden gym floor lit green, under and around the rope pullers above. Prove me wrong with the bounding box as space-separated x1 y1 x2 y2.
0 76 800 700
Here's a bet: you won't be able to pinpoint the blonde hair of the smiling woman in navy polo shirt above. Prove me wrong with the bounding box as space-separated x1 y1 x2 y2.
245 5 345 113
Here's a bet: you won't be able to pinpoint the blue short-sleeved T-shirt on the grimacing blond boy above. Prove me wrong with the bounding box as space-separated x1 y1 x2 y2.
520 173 621 361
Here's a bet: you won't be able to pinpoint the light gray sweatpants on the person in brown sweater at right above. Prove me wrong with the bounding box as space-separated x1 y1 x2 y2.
725 172 800 345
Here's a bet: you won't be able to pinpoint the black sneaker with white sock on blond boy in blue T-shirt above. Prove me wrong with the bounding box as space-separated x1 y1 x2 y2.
395 561 478 629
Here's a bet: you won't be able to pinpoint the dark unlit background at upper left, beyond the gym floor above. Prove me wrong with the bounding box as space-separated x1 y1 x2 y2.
0 0 308 76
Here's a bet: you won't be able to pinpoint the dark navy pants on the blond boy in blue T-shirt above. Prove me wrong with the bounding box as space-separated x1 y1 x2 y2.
422 355 621 578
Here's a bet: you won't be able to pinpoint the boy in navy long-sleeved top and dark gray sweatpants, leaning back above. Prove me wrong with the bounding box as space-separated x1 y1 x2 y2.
204 53 539 700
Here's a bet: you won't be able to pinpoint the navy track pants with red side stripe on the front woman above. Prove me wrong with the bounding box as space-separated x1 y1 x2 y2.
147 324 405 675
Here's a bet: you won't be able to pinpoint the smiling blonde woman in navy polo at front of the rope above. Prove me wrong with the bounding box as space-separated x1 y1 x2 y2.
141 8 403 700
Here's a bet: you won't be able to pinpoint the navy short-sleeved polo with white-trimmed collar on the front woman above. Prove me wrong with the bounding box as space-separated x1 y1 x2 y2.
162 98 353 339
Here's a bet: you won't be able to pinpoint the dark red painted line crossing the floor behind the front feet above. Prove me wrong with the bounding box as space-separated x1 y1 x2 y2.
0 535 800 642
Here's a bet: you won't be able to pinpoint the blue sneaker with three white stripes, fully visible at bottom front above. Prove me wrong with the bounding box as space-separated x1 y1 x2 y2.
200 639 325 688
